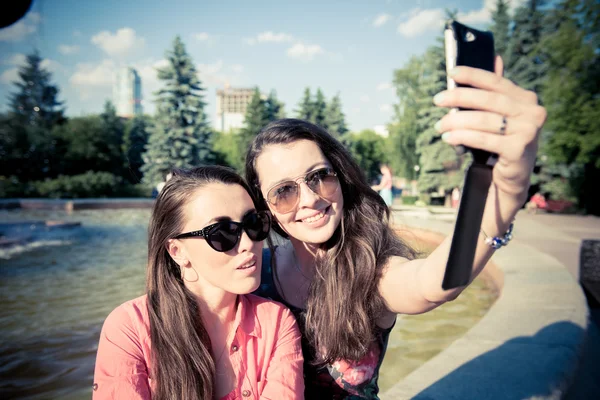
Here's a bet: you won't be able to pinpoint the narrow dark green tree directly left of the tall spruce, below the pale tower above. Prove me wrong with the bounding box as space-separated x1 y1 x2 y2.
123 115 151 183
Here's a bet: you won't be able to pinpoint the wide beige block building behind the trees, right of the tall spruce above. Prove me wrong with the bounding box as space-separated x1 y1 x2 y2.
215 85 254 132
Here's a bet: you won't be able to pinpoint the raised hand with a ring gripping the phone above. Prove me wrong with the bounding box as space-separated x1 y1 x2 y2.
434 57 546 206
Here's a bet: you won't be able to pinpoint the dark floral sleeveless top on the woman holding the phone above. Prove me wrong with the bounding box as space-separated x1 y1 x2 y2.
253 249 393 400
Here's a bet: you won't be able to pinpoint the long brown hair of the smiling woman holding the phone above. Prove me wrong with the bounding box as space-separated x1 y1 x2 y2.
246 119 415 363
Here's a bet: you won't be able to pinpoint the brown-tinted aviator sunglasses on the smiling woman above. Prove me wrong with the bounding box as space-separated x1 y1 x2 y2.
266 168 340 214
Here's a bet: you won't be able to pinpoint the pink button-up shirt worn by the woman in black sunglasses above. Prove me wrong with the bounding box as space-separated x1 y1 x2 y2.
93 294 304 400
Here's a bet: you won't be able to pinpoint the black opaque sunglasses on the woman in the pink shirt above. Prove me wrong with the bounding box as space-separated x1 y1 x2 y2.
174 211 271 252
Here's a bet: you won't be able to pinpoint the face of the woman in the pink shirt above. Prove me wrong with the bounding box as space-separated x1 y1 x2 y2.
168 183 263 295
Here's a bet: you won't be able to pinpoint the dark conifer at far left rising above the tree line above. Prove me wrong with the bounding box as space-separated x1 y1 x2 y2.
10 50 64 129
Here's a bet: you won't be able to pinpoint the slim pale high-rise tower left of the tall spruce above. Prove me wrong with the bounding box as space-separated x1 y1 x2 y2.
113 67 142 118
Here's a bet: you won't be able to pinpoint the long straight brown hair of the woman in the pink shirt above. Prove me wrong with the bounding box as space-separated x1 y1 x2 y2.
146 166 256 400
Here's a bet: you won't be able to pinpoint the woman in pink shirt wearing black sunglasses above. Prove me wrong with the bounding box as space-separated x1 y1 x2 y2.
93 167 304 400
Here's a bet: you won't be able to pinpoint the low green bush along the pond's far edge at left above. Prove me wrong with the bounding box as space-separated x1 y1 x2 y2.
31 171 125 199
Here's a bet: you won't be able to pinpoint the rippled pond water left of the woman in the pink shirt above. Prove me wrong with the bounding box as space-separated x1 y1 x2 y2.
0 210 150 399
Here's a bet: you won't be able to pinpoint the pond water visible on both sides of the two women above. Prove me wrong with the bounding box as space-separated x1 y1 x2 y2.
0 210 495 400
